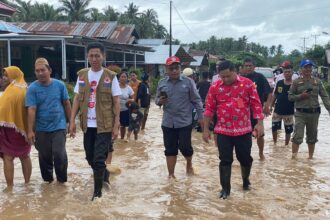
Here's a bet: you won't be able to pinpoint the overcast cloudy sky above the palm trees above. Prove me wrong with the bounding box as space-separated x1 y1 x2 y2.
31 0 330 53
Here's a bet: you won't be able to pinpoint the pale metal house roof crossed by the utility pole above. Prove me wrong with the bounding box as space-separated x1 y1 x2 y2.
145 45 194 64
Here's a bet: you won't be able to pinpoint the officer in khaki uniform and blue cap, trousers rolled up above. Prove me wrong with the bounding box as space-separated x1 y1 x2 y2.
289 59 330 159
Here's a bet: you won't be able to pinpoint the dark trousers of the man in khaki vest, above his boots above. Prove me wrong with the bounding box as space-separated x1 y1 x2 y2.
84 128 112 171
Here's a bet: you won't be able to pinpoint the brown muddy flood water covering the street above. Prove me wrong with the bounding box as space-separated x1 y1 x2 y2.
0 103 330 220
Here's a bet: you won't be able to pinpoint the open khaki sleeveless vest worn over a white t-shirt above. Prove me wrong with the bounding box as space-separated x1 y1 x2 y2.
78 68 116 133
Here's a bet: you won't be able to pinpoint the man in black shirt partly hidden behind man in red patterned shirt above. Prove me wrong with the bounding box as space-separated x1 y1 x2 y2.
242 58 272 160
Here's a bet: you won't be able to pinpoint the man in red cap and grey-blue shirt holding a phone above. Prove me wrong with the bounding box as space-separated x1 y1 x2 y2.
156 56 203 178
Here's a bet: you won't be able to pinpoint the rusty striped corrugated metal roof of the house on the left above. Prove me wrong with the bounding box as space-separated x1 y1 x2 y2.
14 22 117 39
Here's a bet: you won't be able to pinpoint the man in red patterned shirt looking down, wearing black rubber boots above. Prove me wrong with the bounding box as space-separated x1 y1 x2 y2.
203 61 264 199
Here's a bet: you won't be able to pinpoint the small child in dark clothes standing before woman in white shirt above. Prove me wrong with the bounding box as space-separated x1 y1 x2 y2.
126 102 143 142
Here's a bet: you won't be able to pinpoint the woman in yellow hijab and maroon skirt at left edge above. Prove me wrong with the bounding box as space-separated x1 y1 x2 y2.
0 66 32 190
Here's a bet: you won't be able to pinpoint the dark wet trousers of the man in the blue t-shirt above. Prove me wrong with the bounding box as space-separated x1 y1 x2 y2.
35 130 68 183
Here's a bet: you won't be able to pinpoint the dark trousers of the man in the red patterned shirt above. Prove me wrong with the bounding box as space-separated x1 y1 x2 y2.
217 133 253 166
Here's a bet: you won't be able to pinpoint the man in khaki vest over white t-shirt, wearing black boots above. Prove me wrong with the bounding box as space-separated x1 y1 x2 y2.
70 43 121 201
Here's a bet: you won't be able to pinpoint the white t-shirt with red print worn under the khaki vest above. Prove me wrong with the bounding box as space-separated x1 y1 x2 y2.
74 69 121 128
